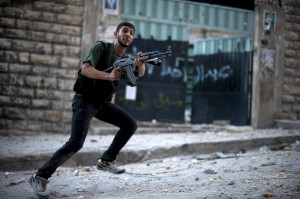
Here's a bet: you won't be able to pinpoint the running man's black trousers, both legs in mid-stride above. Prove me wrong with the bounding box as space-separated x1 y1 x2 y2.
37 95 137 179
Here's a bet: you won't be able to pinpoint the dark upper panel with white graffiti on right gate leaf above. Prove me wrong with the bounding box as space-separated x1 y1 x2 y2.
193 52 251 92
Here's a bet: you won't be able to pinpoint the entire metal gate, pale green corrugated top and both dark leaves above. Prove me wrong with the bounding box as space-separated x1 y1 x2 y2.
116 0 254 125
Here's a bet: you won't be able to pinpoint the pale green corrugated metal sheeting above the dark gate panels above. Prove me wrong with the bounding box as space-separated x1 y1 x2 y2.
121 0 253 41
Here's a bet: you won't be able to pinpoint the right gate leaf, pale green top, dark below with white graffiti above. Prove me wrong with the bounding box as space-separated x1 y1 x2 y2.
191 36 252 125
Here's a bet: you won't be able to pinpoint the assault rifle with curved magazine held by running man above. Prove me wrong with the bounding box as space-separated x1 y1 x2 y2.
104 46 172 86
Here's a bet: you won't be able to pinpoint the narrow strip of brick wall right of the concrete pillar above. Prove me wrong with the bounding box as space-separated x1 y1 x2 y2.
280 0 300 120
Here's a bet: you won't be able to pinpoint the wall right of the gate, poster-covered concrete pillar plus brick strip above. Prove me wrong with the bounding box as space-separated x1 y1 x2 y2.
251 0 300 127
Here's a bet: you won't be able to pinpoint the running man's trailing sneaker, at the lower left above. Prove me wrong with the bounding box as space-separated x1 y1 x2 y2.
28 174 49 198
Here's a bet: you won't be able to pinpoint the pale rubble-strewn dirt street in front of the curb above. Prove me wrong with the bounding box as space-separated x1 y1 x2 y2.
0 143 300 199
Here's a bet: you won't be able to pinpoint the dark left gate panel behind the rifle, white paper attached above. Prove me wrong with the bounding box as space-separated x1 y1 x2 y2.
115 38 188 123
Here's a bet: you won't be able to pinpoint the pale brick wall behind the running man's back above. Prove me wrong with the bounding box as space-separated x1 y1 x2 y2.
0 0 84 135
